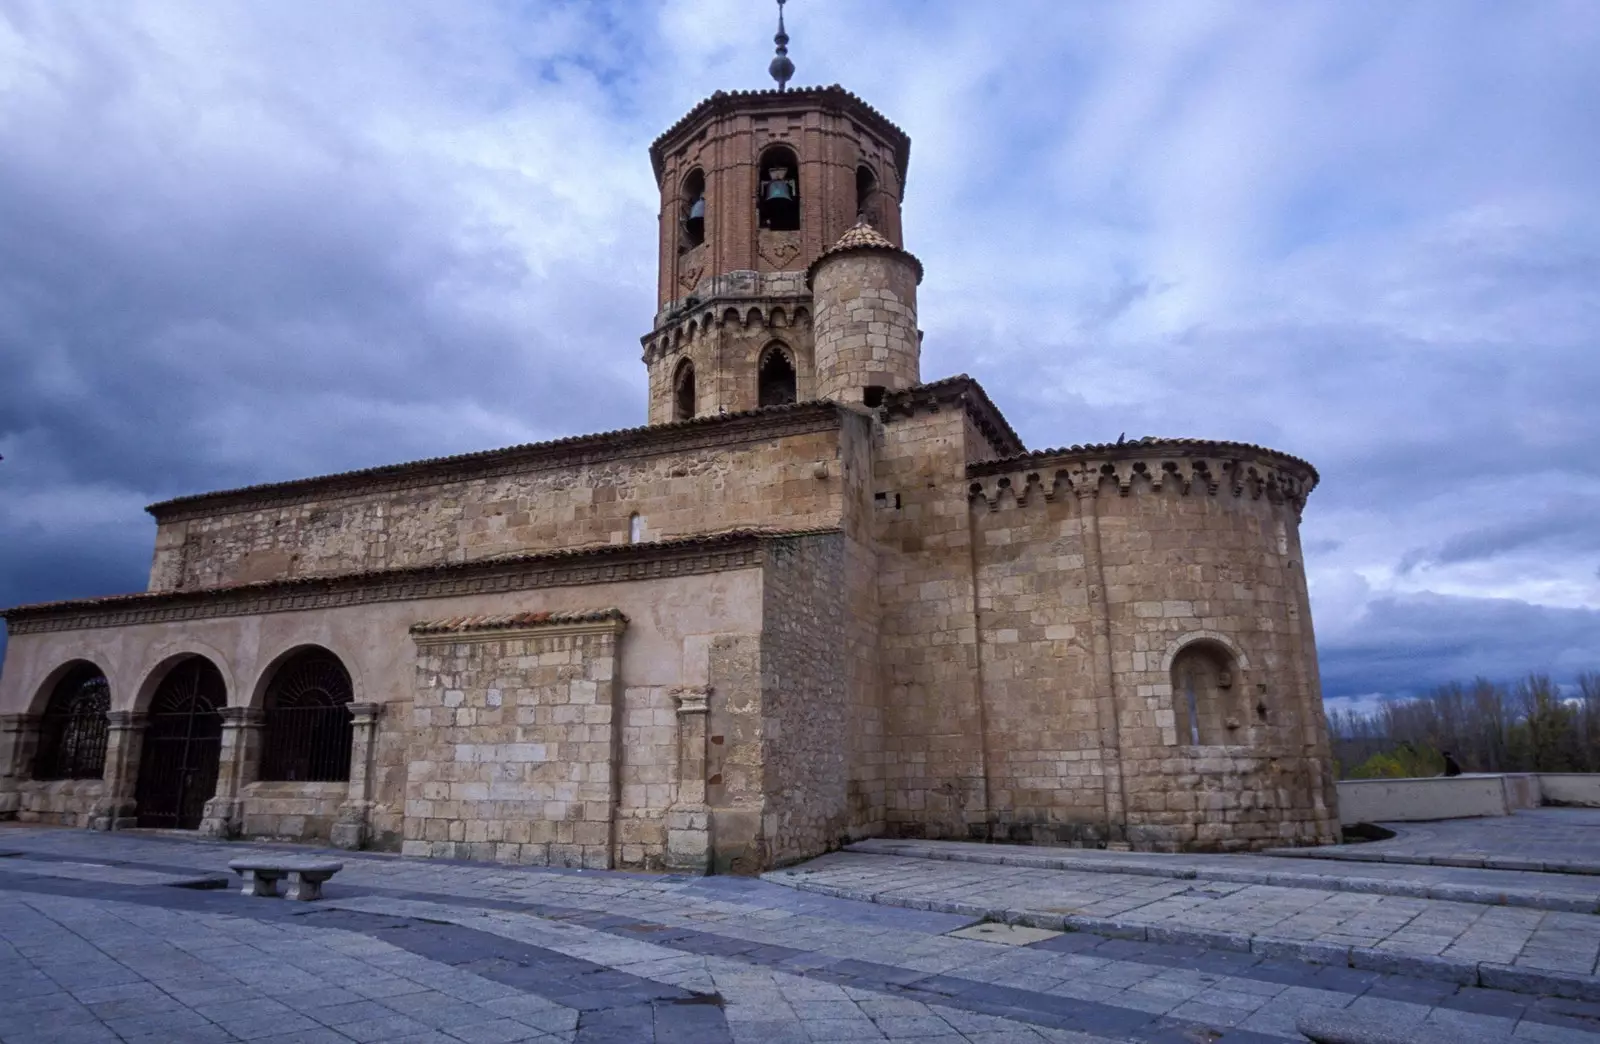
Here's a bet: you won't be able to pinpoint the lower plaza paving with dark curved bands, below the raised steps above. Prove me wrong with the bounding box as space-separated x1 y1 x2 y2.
9 828 1600 1044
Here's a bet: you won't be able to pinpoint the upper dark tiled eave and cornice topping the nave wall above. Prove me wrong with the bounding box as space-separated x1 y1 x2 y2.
146 402 838 522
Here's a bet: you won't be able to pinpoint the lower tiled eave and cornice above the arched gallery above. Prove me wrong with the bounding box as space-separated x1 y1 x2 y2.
0 528 838 636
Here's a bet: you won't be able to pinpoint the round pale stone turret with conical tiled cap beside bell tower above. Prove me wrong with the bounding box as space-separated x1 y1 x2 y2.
806 223 922 407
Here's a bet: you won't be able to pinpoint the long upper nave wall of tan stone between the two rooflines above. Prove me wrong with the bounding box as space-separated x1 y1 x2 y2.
150 404 842 591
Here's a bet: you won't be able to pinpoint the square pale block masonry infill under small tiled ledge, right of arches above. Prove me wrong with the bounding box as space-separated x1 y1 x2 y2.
402 608 627 869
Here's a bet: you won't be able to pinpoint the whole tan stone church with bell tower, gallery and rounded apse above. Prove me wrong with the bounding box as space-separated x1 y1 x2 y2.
0 30 1338 873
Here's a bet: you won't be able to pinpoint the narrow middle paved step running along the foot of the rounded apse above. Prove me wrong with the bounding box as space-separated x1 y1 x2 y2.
845 839 1600 913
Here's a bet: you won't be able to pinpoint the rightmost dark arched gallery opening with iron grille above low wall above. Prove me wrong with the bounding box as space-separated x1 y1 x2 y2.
261 648 354 783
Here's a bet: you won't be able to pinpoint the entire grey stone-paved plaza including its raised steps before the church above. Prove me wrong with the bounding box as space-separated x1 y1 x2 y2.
0 823 1600 1044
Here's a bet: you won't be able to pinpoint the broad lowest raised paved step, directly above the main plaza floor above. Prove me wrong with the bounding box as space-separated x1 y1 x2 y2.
766 852 1600 1001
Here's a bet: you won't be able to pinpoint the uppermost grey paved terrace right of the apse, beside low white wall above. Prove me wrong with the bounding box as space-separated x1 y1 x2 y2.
1267 809 1600 876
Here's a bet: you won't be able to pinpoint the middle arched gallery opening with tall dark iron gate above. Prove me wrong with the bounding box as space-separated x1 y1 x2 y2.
136 657 227 829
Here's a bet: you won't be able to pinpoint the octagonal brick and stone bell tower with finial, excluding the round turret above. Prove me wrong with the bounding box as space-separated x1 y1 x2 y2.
642 0 910 424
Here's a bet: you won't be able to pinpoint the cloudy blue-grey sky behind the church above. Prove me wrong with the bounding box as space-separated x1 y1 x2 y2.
0 0 1600 705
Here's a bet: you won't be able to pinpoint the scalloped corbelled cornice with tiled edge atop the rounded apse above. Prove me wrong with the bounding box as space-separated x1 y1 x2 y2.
966 439 1317 516
